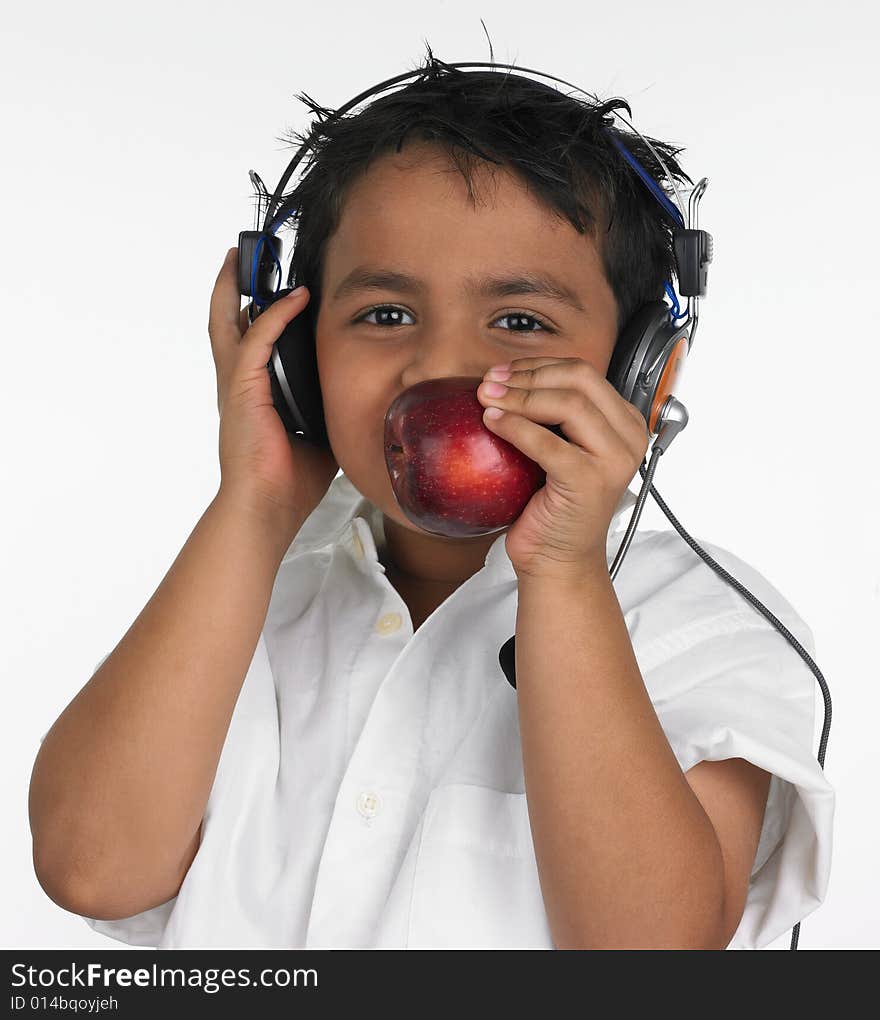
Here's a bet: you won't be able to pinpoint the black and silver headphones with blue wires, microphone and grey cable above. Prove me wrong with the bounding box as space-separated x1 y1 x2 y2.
238 57 831 950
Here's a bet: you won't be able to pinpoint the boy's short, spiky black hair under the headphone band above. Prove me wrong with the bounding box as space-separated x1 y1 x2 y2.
277 46 693 333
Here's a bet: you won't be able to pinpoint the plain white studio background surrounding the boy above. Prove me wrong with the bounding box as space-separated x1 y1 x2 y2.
0 0 880 949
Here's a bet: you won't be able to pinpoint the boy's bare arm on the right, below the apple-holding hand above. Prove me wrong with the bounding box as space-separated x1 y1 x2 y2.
516 561 769 949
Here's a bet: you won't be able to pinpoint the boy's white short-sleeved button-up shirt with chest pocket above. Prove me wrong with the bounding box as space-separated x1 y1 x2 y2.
68 474 834 949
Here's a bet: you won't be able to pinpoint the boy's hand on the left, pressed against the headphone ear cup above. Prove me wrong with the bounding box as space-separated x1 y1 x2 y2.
208 248 339 527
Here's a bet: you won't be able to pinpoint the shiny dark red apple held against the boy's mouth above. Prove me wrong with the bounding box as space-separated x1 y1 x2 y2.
384 375 564 539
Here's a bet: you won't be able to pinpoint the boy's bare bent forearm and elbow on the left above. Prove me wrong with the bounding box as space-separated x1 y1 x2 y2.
29 491 302 919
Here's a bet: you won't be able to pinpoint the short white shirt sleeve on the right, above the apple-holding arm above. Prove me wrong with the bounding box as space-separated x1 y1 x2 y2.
643 600 834 949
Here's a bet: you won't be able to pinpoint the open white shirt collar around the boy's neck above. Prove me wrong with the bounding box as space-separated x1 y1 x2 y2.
284 471 636 581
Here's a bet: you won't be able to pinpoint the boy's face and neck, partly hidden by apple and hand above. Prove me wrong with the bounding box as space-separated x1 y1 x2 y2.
316 142 617 587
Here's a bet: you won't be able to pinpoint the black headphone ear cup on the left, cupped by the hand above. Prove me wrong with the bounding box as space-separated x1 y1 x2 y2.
261 288 330 449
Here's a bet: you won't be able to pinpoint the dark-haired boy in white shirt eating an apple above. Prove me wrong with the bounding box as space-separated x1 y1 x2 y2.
32 53 833 949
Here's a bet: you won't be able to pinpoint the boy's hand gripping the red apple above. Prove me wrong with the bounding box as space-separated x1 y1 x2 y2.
477 357 651 579
